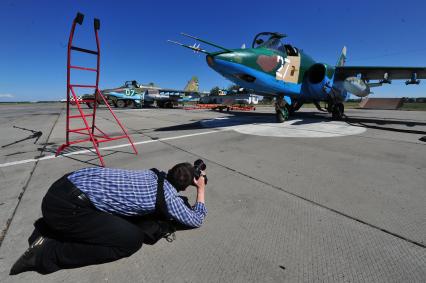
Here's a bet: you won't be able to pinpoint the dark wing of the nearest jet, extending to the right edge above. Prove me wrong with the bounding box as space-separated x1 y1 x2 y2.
335 66 426 81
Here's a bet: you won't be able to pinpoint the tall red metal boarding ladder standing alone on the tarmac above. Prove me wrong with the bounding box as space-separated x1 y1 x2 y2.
56 13 138 167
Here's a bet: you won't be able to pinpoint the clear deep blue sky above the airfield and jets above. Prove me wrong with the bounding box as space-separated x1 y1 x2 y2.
0 0 426 101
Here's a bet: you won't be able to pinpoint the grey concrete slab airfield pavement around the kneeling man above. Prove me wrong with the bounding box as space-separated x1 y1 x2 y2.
0 103 426 282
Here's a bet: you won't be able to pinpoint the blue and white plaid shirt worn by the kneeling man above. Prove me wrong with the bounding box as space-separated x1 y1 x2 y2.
68 167 207 227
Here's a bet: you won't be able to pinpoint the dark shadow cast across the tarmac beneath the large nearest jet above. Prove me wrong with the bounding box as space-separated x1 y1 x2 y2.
155 112 426 139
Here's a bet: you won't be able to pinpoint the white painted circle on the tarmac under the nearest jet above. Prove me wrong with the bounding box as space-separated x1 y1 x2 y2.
201 117 366 138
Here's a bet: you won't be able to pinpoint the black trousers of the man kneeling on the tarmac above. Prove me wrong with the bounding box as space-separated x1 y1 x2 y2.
35 175 144 273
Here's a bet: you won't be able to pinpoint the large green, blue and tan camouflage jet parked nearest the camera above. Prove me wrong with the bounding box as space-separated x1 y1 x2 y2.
169 32 426 122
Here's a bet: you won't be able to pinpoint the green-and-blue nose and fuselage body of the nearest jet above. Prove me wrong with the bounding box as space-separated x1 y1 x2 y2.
206 47 347 104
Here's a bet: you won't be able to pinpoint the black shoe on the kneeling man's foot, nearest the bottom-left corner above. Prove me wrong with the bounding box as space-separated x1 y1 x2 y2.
9 236 48 275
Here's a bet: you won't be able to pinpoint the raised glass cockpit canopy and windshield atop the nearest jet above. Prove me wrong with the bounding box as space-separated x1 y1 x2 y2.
252 32 299 56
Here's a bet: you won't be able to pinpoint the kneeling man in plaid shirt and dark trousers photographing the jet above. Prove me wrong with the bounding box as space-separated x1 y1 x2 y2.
10 159 207 275
